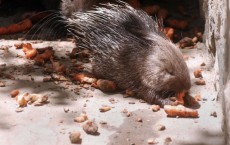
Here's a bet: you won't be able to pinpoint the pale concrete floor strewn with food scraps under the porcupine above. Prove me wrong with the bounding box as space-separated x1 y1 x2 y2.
0 40 224 145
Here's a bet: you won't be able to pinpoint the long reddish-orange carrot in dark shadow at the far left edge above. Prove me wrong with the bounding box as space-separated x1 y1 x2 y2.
0 19 32 35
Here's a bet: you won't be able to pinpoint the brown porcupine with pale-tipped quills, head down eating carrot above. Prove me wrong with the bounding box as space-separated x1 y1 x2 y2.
61 0 191 107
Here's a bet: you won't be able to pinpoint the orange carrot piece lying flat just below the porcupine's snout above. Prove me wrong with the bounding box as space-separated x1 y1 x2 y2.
164 105 199 118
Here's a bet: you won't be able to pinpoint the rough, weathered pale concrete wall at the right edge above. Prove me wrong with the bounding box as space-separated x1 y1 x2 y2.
201 0 230 145
